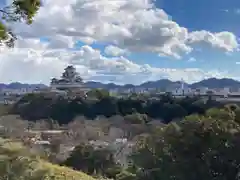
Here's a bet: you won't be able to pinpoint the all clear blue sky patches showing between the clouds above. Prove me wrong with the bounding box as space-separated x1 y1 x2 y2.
75 0 240 76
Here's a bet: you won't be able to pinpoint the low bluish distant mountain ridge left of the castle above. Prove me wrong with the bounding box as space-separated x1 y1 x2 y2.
0 82 47 89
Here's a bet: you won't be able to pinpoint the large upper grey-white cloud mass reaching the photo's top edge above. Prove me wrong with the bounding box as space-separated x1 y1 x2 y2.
12 0 238 58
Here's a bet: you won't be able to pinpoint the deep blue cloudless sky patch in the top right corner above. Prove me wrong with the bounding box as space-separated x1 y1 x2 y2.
156 0 240 33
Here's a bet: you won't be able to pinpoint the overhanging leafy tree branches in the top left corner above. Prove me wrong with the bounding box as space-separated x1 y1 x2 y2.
0 0 41 47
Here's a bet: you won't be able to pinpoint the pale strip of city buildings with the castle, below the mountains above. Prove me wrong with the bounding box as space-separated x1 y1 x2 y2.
0 65 240 104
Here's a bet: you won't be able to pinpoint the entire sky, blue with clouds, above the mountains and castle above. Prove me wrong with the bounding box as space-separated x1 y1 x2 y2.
0 0 240 84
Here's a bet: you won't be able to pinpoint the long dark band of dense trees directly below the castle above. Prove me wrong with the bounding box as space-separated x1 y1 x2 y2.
11 94 222 124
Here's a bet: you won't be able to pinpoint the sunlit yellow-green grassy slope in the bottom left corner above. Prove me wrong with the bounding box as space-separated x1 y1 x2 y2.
0 138 95 180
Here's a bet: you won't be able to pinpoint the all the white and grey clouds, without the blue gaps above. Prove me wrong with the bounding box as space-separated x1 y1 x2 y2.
0 0 238 84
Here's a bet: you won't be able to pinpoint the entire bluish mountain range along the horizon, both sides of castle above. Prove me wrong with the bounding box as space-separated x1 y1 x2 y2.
0 78 240 89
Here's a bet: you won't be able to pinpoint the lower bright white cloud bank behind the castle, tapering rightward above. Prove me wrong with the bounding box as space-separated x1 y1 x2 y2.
0 40 231 84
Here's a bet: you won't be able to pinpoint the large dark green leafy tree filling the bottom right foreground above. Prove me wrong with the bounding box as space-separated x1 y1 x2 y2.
131 117 240 180
